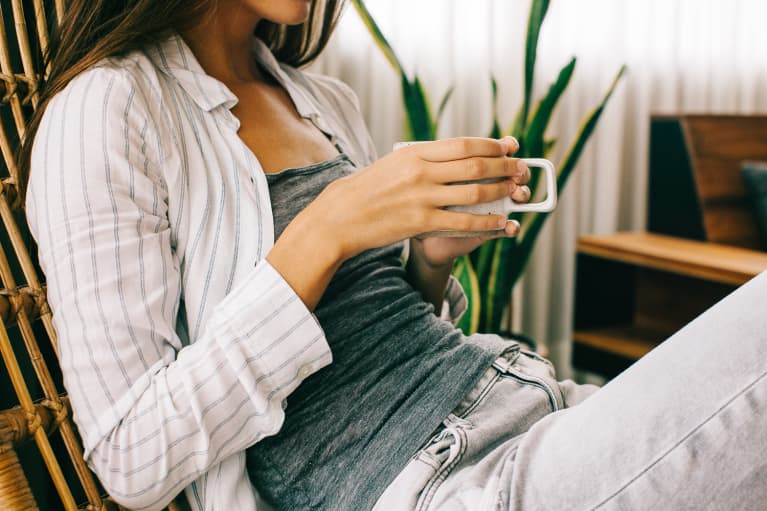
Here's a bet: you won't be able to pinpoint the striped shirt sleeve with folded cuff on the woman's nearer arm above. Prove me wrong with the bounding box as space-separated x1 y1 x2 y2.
26 68 331 509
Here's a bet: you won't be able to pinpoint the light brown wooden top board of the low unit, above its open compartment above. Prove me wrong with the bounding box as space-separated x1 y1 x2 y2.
577 232 767 285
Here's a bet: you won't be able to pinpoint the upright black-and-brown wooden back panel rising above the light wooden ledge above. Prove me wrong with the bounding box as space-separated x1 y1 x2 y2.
647 115 767 248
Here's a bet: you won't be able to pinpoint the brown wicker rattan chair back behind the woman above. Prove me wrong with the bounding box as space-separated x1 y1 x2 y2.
0 0 188 511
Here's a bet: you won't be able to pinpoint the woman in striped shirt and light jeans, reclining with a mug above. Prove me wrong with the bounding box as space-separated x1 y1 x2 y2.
22 0 767 510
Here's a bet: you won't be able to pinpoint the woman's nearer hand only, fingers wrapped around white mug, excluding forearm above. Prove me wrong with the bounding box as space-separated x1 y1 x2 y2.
303 137 519 259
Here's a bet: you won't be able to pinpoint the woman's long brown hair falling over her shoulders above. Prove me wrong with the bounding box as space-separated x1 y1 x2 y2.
18 0 345 203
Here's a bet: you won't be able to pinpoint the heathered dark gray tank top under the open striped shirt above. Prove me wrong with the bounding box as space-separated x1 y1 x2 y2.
247 155 507 511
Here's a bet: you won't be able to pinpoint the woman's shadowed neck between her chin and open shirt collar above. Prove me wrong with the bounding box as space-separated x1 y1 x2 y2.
181 2 263 84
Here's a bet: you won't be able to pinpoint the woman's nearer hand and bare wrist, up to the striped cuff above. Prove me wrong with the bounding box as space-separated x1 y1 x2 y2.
267 137 524 308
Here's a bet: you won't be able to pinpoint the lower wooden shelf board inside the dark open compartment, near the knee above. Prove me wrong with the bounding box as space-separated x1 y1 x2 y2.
573 325 672 360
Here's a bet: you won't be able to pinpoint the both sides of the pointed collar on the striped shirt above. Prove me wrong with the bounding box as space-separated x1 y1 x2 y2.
147 33 319 118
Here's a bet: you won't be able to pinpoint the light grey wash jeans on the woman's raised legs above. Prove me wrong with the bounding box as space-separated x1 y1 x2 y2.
375 272 767 511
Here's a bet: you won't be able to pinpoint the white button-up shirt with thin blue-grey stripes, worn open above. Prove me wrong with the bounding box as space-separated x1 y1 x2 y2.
26 35 465 511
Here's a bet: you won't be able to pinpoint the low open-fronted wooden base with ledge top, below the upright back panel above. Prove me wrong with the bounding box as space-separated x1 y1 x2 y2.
573 232 767 378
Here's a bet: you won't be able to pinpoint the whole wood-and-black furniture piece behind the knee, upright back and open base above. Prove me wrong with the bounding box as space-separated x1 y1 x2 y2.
573 115 767 378
